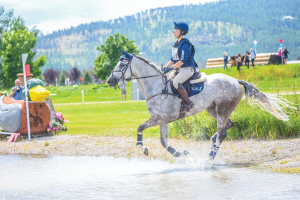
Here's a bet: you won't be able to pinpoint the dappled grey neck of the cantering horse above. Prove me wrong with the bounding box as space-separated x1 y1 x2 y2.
131 58 163 99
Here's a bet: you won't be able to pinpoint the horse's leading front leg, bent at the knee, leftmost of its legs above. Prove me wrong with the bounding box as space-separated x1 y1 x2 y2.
136 116 165 156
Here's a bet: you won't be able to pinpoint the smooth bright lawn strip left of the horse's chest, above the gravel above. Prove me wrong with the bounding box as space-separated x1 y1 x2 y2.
54 102 159 138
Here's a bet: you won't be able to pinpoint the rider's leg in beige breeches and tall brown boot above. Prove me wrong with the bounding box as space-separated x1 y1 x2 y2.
173 67 194 113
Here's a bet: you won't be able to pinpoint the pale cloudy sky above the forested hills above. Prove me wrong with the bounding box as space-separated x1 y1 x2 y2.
0 0 215 34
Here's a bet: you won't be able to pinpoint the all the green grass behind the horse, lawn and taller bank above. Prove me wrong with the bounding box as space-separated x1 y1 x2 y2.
0 64 300 140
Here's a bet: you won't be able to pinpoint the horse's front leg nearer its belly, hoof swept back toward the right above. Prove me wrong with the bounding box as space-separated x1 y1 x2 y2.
159 124 189 157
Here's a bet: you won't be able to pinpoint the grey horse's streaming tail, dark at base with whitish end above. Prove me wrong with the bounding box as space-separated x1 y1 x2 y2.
238 80 295 121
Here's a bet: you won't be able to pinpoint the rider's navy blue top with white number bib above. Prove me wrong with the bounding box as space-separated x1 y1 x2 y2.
171 38 195 67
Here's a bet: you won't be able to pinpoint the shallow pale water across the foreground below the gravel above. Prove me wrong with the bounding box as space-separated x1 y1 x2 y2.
0 156 300 200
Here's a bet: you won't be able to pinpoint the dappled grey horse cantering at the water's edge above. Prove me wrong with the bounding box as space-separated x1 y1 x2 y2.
106 51 290 160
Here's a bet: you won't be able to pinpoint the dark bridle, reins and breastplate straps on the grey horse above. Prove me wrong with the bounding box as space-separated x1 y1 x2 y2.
111 55 178 102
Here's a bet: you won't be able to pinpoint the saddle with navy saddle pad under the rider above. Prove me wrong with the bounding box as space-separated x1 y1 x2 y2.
170 72 206 98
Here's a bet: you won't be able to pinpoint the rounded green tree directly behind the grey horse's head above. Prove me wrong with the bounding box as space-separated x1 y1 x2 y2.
94 33 139 80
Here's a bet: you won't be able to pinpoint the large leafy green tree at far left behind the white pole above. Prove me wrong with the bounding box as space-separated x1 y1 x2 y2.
0 16 46 84
